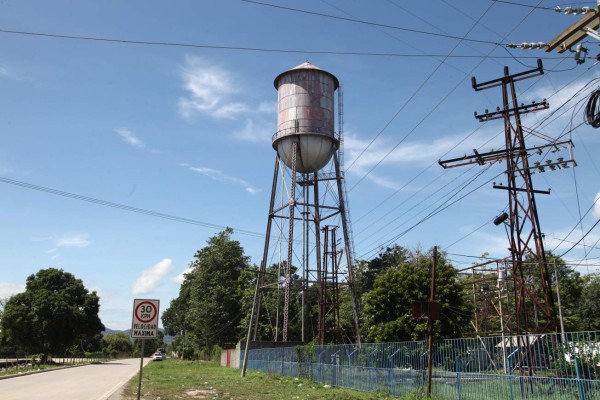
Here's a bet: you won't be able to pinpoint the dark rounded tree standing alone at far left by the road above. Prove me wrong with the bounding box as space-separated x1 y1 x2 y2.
0 268 104 356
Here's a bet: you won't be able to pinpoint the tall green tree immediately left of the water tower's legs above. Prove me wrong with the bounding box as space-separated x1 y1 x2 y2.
163 228 249 348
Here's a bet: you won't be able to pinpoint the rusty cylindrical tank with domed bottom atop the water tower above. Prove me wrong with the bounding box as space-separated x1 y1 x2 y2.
273 62 339 173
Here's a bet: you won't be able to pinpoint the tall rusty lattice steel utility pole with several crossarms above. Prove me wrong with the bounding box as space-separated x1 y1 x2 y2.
439 59 577 373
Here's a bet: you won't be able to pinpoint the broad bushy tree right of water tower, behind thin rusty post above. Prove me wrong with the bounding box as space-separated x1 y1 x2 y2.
362 251 471 342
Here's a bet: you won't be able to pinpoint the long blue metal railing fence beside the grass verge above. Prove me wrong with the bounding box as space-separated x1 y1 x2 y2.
240 332 600 400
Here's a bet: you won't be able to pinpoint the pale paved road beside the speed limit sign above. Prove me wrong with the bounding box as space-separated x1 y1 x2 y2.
0 358 150 400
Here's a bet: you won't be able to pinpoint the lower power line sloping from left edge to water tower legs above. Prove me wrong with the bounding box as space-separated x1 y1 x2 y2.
0 177 265 237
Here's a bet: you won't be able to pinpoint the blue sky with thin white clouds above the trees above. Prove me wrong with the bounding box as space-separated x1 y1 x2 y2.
0 0 600 329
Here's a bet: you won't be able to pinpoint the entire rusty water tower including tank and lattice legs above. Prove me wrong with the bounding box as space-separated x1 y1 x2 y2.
248 62 360 344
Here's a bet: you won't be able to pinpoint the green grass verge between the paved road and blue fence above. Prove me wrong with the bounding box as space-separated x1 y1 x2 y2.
123 359 408 400
